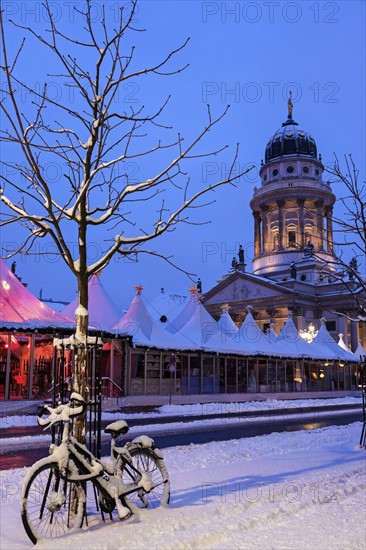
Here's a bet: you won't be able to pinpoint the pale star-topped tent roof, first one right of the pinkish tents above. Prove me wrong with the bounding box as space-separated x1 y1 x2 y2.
113 287 195 349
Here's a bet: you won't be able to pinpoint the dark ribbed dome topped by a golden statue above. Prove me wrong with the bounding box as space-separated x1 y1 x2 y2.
265 97 317 162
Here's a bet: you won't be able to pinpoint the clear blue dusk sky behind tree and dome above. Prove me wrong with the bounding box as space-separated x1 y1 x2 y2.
1 0 366 307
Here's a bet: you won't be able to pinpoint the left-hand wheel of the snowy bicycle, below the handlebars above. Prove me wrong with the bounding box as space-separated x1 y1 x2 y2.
21 462 85 544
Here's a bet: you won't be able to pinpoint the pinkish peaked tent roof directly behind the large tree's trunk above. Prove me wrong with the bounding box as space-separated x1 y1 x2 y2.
61 275 122 331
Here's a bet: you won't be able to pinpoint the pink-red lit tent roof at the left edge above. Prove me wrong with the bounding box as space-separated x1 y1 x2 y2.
0 258 75 330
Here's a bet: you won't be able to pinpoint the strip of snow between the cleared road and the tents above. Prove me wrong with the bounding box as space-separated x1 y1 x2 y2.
0 397 362 429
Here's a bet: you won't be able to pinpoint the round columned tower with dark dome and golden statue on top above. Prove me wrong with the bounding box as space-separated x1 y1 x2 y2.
250 97 336 282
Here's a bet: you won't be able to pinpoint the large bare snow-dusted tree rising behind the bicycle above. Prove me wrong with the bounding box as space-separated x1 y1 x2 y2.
0 0 249 440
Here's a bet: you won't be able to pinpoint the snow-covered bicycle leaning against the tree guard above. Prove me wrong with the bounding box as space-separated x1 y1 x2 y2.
21 392 170 544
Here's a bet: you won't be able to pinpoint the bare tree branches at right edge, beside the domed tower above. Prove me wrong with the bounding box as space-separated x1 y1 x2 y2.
326 155 366 321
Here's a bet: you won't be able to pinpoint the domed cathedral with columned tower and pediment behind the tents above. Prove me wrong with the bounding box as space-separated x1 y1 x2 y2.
204 95 366 351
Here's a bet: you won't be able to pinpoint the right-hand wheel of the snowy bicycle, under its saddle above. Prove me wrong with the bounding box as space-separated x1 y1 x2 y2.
121 445 170 508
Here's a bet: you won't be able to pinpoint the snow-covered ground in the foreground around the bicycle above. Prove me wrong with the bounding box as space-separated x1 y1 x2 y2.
0 422 366 550
